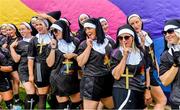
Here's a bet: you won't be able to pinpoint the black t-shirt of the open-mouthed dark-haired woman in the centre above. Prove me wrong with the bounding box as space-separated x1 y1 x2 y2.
78 40 112 76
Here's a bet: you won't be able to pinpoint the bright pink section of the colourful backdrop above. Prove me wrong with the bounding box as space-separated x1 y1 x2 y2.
21 0 126 39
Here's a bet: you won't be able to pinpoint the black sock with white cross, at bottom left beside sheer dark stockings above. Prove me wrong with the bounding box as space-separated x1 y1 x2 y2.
24 94 35 110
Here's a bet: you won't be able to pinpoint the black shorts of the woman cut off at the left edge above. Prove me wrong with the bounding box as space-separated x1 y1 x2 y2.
0 77 12 92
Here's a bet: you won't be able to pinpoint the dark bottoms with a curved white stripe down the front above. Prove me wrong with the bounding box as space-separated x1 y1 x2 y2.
113 87 146 109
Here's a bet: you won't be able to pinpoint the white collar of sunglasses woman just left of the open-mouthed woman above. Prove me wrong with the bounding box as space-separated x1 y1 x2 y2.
58 39 76 53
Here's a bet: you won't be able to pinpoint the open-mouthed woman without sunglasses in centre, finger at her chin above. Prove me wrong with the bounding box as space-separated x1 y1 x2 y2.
77 18 113 109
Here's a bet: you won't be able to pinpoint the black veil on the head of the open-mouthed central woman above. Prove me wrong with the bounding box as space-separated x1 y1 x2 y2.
85 18 105 44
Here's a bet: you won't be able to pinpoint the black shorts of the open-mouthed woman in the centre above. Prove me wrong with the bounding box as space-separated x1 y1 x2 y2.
80 74 114 101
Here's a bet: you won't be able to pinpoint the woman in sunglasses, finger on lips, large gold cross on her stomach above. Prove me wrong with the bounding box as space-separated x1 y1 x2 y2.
111 24 146 109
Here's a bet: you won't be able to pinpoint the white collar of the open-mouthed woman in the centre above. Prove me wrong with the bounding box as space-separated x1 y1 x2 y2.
92 38 109 54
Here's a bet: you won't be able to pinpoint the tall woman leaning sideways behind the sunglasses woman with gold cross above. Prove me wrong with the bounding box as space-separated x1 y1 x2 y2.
128 14 167 110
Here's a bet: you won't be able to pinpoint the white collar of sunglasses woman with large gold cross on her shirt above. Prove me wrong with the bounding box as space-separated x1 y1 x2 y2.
119 46 142 65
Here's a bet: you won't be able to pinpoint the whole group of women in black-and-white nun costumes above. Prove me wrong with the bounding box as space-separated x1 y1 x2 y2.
0 11 180 109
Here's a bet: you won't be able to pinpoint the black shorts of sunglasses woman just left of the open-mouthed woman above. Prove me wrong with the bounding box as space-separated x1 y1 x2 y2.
50 73 80 96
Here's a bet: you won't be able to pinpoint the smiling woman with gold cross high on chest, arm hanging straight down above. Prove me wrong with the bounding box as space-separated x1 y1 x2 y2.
28 17 53 109
